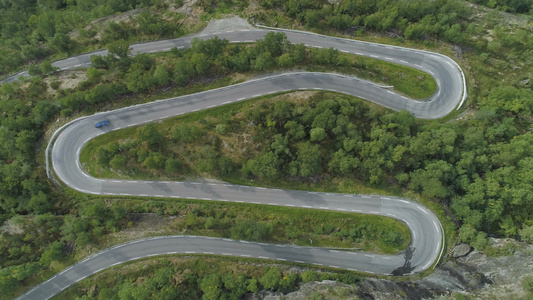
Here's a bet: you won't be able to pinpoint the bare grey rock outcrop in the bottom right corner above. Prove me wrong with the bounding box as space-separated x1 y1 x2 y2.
251 239 533 300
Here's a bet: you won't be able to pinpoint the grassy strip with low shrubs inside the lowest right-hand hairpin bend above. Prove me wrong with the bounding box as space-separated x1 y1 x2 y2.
63 196 410 259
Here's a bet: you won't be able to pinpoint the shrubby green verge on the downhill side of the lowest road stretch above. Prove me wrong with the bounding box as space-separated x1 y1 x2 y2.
53 254 361 299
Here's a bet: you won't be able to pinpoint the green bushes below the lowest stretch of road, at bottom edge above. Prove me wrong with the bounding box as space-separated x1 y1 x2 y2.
60 256 359 300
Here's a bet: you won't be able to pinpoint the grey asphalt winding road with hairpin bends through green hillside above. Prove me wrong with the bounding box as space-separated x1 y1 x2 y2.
12 29 466 299
